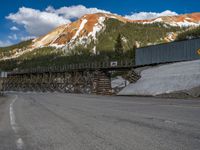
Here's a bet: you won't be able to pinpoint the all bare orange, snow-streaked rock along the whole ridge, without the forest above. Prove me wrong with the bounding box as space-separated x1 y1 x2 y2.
32 13 200 49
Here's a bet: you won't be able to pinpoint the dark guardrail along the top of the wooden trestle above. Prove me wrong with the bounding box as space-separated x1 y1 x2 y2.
9 60 134 74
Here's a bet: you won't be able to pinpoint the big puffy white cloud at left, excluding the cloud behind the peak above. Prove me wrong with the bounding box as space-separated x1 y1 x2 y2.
6 7 70 36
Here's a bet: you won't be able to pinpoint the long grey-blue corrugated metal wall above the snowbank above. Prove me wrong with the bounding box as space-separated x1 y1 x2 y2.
136 39 200 65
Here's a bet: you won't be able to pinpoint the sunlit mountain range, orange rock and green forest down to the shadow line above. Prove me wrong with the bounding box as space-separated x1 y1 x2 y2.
0 13 200 60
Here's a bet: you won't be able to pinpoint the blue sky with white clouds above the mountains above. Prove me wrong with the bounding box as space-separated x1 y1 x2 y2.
0 0 200 46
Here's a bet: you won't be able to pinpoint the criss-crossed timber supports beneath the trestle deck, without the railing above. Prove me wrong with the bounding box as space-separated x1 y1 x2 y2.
4 71 112 95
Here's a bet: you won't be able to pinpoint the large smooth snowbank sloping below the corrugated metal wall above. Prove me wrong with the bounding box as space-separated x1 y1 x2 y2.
118 60 200 96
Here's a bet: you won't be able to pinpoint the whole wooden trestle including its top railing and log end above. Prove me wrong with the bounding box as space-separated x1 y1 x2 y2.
4 61 139 95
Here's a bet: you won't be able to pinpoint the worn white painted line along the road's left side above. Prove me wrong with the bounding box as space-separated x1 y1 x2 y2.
10 95 24 150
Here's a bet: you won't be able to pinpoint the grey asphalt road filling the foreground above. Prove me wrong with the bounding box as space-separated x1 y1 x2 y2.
0 93 200 150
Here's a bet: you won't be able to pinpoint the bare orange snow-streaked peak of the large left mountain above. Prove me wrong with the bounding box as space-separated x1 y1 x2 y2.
32 13 130 49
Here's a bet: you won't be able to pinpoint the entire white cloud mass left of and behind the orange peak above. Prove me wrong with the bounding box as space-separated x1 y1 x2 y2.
6 5 109 36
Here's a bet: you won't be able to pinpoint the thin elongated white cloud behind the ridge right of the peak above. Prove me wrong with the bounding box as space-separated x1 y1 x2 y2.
125 10 178 20
